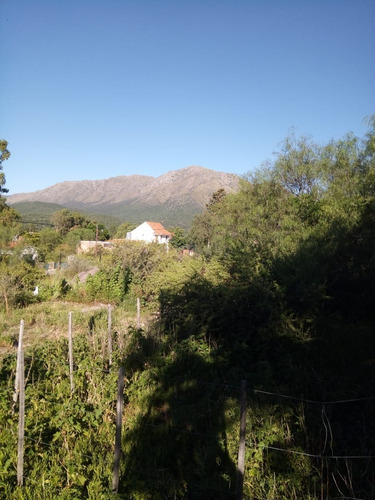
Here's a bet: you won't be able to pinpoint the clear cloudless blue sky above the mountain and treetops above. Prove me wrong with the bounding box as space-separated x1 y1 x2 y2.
0 0 375 194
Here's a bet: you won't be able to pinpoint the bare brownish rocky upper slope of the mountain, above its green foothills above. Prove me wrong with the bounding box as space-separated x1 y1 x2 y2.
7 167 239 209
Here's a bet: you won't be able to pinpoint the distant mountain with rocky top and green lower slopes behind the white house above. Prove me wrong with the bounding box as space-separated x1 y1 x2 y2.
7 166 239 227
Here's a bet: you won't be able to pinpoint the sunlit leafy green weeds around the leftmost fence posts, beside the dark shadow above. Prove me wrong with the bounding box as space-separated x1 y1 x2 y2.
0 328 116 499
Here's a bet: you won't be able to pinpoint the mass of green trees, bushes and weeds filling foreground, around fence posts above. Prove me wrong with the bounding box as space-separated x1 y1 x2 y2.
0 120 375 500
